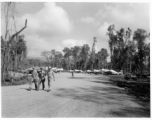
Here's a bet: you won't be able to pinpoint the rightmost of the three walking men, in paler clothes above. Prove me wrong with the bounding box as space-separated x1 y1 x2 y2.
47 67 55 92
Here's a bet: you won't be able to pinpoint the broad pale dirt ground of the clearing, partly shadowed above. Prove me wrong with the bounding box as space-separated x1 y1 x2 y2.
1 73 150 118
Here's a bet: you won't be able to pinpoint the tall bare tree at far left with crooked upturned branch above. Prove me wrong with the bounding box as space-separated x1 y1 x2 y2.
1 2 27 81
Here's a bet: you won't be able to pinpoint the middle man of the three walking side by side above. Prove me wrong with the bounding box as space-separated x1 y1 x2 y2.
38 67 46 90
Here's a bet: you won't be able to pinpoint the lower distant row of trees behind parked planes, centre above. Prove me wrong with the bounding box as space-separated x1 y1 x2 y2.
41 44 108 70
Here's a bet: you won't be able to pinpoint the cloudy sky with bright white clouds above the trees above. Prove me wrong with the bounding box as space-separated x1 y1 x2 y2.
1 2 150 60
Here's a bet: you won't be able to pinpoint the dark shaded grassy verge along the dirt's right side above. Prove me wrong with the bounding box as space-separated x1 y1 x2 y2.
110 76 150 102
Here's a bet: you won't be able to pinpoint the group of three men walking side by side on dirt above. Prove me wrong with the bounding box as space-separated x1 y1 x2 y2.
29 67 55 92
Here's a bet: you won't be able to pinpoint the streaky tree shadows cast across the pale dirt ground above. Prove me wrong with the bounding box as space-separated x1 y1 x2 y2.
53 77 150 117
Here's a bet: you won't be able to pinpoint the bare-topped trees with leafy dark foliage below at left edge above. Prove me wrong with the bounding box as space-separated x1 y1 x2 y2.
1 2 27 82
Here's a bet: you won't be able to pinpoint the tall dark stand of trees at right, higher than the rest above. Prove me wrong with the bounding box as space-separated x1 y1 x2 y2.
107 25 150 74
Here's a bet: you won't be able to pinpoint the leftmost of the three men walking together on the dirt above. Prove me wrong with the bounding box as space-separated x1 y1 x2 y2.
29 67 39 91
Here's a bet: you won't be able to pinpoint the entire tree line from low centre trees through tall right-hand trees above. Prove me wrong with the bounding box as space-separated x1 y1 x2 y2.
41 25 150 74
